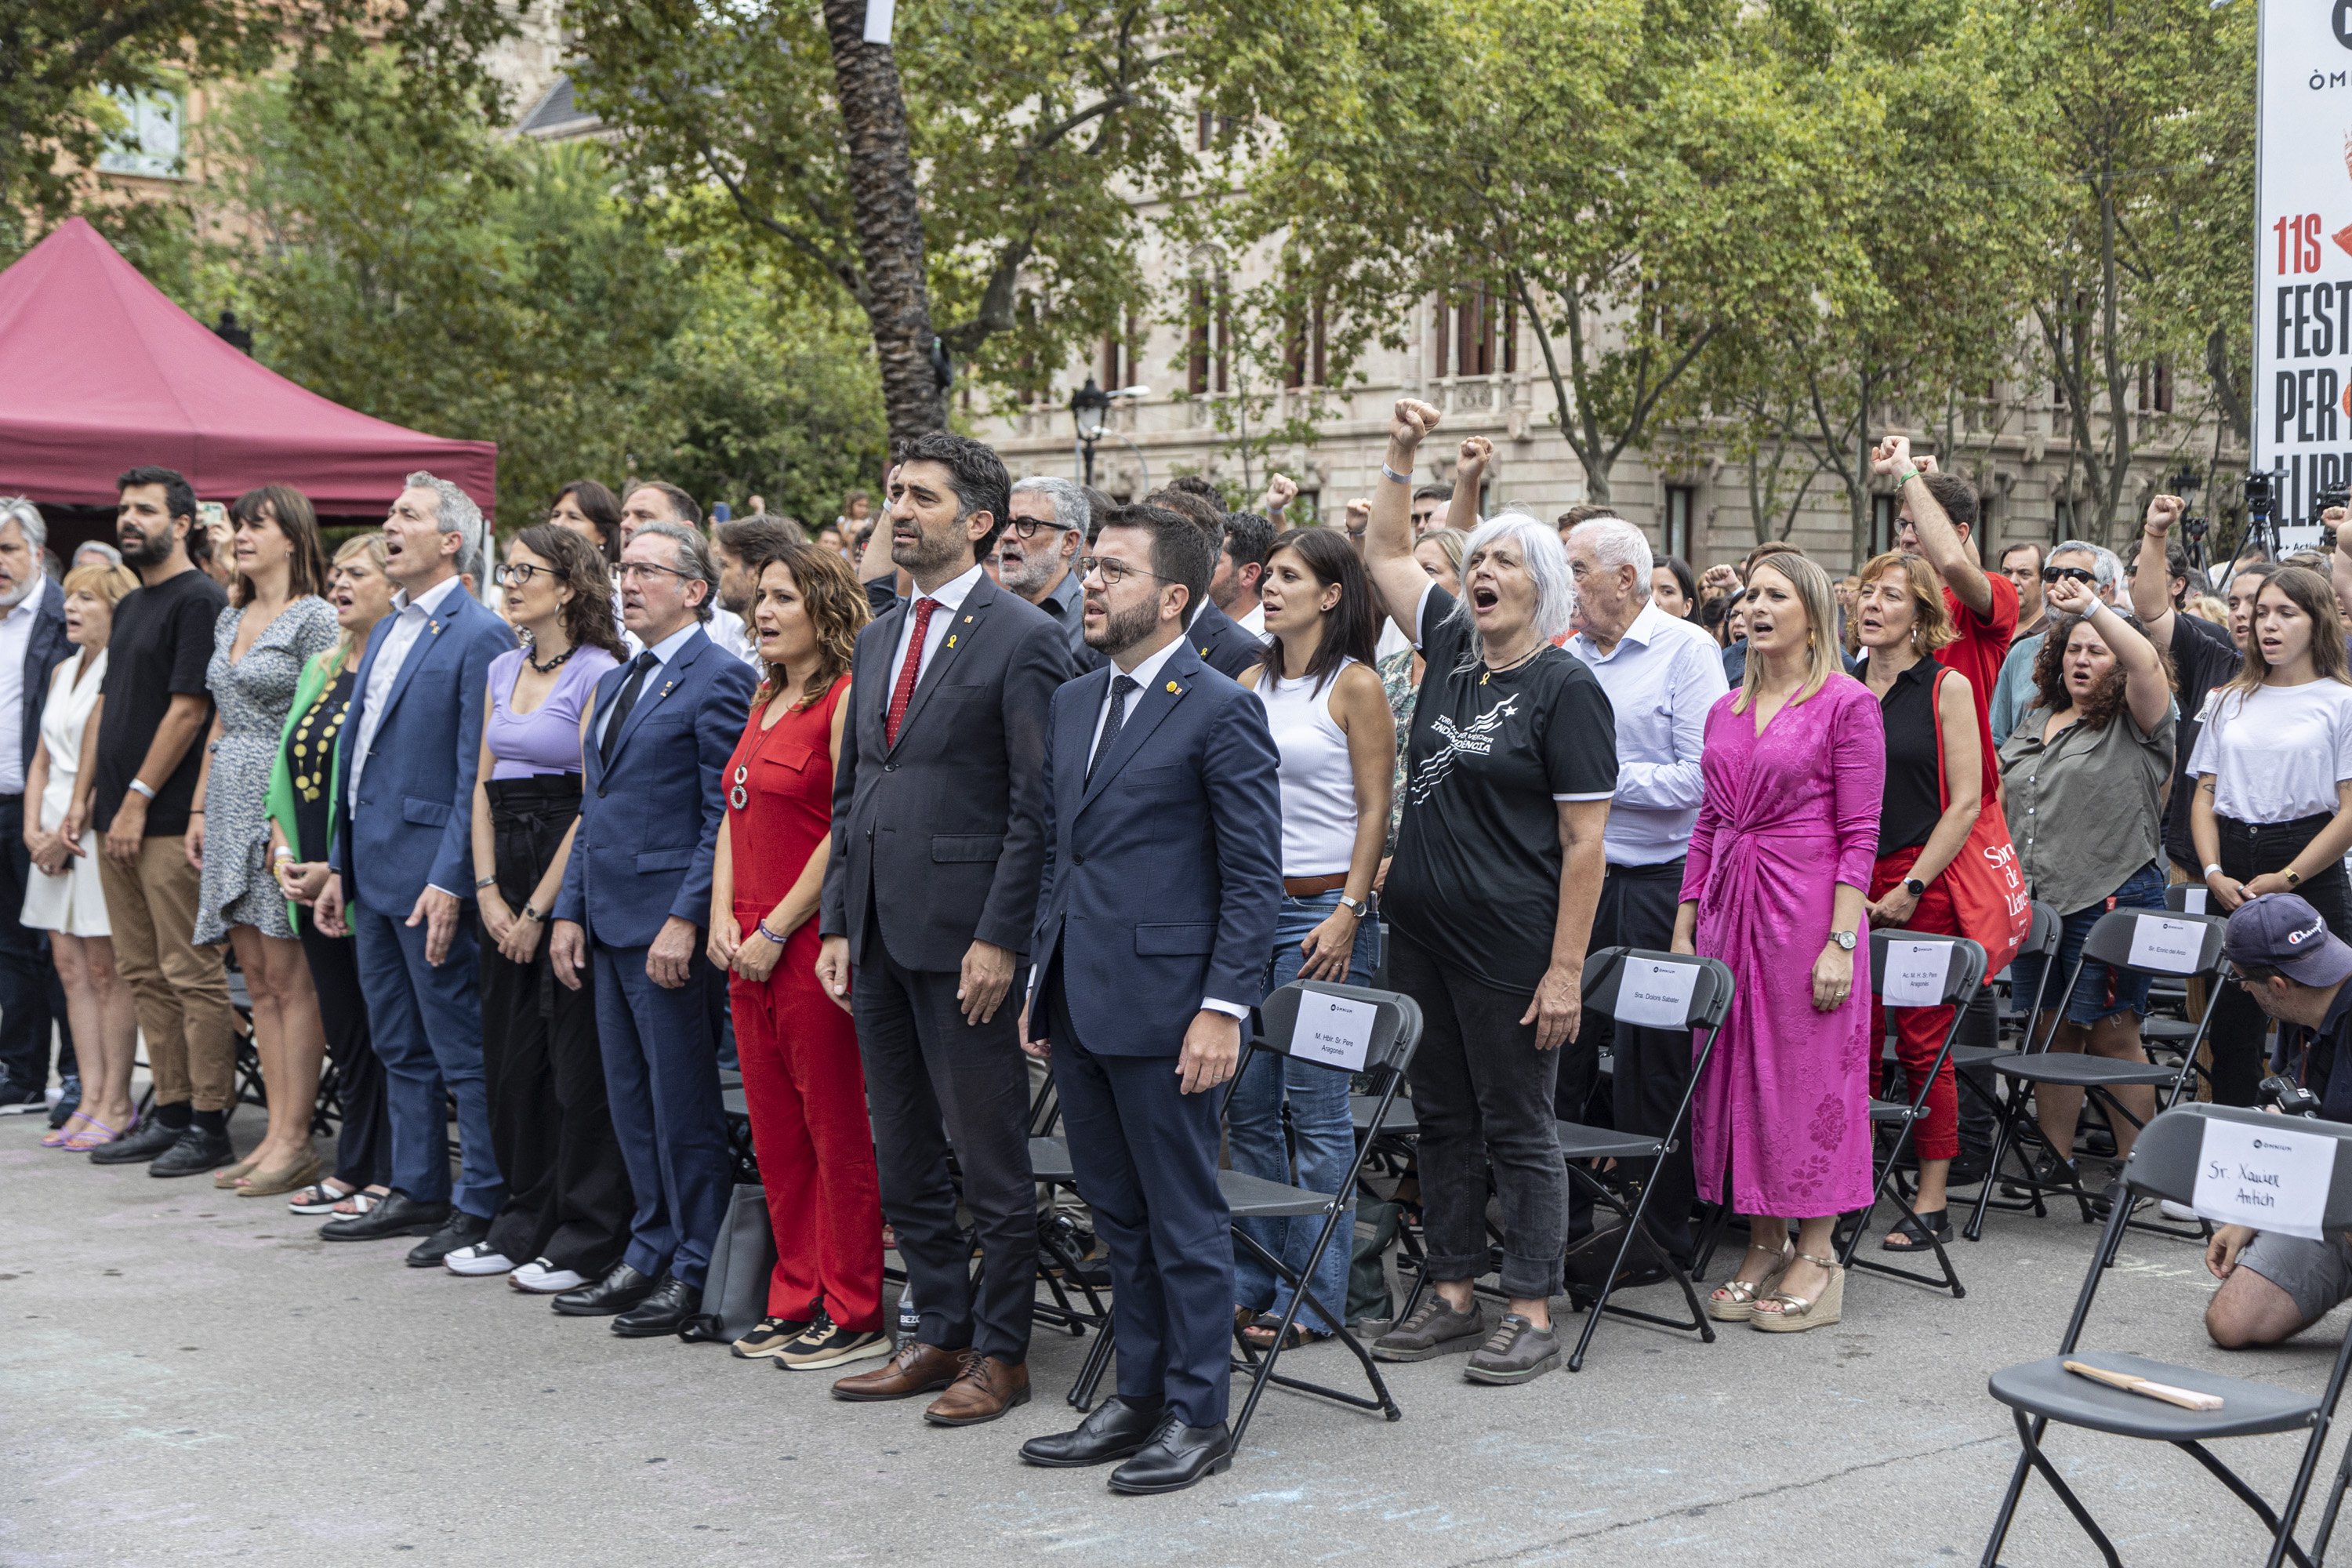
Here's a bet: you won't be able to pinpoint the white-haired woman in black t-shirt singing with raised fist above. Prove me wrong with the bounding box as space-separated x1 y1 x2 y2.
1364 397 1616 1382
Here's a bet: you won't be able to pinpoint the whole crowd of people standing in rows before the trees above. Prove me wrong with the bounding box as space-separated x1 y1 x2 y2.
13 400 2352 1493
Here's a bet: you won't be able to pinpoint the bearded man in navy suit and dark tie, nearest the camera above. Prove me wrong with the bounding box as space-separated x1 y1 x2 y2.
1021 506 1282 1493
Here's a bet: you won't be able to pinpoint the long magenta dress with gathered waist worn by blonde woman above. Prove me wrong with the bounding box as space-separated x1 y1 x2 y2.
1682 675 1886 1218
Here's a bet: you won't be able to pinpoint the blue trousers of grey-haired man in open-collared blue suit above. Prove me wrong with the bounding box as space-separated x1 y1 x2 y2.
350 900 506 1220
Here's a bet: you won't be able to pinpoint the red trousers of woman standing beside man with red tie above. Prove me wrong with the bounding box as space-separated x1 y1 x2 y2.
727 909 882 1330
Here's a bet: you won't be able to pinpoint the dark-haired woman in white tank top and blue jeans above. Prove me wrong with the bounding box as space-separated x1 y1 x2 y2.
1228 529 1397 1347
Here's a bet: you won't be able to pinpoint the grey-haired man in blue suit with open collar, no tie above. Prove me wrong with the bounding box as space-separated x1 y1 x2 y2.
315 473 515 1267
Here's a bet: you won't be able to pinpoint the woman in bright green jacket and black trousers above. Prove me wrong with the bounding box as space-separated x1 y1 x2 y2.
268 545 393 1215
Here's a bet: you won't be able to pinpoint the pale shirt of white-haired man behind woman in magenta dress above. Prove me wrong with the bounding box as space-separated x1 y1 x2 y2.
1566 604 1731 865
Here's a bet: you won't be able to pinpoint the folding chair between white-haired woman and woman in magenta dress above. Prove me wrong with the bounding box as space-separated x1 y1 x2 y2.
1555 947 1733 1373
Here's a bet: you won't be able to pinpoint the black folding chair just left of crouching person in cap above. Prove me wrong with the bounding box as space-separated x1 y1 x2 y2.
1969 909 2230 1241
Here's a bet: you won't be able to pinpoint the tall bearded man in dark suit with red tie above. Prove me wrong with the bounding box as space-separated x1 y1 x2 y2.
816 435 1073 1427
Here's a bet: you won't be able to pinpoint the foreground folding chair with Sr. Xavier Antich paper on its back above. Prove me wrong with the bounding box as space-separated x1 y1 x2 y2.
1980 1105 2352 1568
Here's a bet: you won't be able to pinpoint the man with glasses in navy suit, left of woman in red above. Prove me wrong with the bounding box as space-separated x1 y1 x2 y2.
548 522 757 1338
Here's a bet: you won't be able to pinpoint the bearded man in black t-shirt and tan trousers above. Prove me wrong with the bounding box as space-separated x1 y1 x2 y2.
66 468 238 1175
